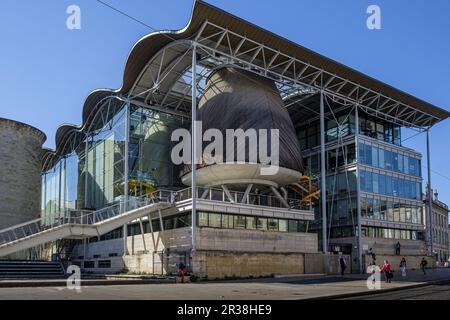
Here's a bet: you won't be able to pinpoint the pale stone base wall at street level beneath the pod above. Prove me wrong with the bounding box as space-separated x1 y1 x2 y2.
72 228 323 278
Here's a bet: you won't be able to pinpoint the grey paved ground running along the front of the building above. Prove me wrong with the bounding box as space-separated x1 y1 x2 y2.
0 269 450 300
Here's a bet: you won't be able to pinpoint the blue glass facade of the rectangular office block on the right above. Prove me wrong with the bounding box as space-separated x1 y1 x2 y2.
297 110 424 247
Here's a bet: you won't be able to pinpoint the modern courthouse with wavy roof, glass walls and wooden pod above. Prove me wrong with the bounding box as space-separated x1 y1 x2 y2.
0 1 449 277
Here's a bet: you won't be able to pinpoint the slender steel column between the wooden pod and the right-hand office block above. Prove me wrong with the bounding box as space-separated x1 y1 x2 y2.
320 90 328 254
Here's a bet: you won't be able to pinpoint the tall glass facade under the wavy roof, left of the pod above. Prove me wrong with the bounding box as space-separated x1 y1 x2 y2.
41 98 185 224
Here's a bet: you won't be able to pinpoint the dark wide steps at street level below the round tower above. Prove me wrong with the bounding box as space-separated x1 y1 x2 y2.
0 260 66 280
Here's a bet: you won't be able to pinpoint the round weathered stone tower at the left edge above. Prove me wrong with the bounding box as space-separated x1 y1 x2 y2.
0 118 46 229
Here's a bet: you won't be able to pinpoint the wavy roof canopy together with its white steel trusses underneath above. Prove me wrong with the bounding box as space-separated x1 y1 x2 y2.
44 1 450 169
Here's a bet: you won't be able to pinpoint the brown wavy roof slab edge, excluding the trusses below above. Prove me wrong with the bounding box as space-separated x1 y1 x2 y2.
44 0 450 170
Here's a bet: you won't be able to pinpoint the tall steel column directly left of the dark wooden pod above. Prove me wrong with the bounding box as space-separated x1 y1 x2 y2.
191 42 197 252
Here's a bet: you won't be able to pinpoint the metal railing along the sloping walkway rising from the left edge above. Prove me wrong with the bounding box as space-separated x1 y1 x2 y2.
0 190 174 245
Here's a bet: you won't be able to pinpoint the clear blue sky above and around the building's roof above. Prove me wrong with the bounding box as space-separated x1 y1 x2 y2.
0 0 450 203
